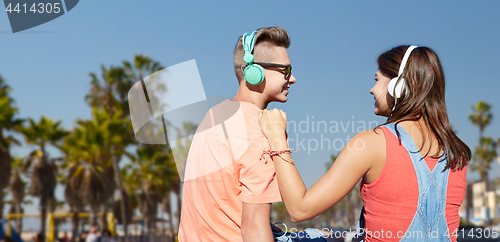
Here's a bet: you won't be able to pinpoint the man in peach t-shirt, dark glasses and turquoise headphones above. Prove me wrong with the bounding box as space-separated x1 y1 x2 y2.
179 27 296 242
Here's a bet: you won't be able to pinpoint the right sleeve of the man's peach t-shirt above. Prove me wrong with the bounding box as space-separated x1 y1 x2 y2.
239 137 281 203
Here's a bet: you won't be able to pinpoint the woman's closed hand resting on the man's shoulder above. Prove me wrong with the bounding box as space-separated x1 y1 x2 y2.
259 108 287 148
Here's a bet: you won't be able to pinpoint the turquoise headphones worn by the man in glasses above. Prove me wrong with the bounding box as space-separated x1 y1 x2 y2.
241 31 265 85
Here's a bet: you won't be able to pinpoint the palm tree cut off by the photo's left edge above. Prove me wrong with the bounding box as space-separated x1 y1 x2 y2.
0 76 23 218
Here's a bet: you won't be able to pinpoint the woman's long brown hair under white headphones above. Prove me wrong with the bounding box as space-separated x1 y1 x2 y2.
377 45 471 171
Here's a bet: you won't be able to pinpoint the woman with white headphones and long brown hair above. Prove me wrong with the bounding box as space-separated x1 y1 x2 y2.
259 46 471 241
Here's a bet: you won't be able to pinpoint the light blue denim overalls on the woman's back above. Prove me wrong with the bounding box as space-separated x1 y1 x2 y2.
358 123 453 241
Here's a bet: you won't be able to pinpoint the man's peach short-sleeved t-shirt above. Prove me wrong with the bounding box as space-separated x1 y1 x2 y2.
179 100 281 242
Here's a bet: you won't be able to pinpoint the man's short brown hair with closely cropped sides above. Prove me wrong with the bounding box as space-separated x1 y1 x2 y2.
233 27 290 80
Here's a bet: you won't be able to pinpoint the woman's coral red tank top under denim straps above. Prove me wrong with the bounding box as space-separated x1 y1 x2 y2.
361 127 467 242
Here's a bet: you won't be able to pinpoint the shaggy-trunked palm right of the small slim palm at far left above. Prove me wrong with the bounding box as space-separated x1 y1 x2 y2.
19 116 68 237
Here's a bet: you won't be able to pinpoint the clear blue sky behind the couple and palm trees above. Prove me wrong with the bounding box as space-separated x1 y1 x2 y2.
0 1 500 216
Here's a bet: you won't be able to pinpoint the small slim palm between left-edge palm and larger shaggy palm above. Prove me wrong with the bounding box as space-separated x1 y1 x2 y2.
10 158 26 234
